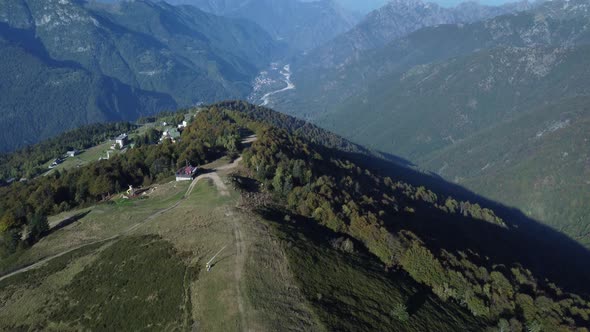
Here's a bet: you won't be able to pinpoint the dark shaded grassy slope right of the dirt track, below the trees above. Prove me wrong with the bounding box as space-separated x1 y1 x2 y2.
268 217 482 331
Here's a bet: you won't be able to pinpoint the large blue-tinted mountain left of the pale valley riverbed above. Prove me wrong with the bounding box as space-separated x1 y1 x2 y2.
0 0 281 151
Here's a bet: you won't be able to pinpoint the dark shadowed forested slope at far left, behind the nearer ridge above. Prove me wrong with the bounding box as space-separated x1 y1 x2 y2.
0 26 177 152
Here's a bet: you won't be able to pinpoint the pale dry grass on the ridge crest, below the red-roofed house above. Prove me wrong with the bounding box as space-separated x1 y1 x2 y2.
138 181 243 331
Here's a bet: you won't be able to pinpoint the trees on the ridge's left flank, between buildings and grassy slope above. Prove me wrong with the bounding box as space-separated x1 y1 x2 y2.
0 109 240 256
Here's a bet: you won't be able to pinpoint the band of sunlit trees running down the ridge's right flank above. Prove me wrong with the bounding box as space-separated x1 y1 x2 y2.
244 126 590 331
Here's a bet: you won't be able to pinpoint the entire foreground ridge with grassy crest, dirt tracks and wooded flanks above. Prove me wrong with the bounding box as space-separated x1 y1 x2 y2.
0 102 590 331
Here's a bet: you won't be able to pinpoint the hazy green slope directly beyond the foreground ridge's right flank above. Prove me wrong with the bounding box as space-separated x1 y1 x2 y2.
320 45 590 162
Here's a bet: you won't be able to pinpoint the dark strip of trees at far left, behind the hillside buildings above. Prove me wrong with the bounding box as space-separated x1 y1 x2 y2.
0 122 136 181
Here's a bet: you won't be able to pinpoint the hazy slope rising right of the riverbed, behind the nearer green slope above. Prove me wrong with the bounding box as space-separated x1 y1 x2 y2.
280 0 590 118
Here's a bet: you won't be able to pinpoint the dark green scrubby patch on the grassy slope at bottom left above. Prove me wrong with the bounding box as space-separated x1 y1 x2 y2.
51 236 191 331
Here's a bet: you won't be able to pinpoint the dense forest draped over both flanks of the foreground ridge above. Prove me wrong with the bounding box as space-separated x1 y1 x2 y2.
0 102 590 331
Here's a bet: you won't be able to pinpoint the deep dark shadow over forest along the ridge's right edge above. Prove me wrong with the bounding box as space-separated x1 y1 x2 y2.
318 147 590 294
